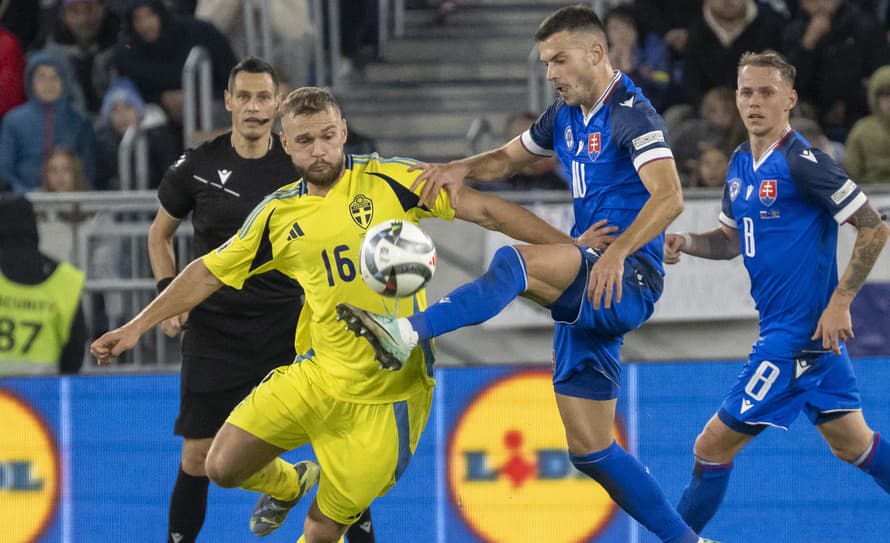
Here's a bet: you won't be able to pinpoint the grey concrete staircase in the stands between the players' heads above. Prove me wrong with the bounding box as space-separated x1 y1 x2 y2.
336 0 571 161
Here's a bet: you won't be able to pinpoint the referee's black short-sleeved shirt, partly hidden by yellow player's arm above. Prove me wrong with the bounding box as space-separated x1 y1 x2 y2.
158 132 303 391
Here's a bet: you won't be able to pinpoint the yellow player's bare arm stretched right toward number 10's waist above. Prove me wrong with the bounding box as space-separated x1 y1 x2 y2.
454 186 574 244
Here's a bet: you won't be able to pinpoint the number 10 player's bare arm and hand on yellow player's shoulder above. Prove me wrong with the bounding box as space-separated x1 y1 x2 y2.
409 137 539 208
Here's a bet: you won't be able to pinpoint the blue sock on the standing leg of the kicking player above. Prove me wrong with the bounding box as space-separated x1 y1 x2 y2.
571 441 698 543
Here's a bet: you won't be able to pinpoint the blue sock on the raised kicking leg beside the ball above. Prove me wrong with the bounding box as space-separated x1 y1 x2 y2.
408 247 528 341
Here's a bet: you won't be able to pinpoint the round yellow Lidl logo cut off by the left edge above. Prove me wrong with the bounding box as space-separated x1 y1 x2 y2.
0 389 59 543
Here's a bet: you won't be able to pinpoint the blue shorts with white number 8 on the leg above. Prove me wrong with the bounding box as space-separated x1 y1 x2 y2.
717 345 862 435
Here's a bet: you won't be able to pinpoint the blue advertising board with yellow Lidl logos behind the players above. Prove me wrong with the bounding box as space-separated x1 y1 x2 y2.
0 359 890 543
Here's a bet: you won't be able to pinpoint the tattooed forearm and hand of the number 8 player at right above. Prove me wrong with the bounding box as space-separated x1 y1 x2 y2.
812 202 890 354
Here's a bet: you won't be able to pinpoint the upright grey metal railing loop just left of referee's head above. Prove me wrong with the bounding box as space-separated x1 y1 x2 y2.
182 46 213 147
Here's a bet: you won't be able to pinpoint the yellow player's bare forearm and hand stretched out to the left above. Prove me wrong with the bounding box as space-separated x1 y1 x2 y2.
90 258 222 366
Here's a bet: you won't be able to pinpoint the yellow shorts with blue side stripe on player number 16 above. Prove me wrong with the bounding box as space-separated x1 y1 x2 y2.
226 364 433 524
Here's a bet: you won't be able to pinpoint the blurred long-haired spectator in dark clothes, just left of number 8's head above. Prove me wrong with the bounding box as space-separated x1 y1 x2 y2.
670 87 745 186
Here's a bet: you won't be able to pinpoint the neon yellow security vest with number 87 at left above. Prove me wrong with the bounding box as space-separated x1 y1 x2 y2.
0 262 84 375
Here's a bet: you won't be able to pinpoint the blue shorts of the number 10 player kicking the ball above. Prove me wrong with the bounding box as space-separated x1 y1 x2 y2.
550 248 664 400
